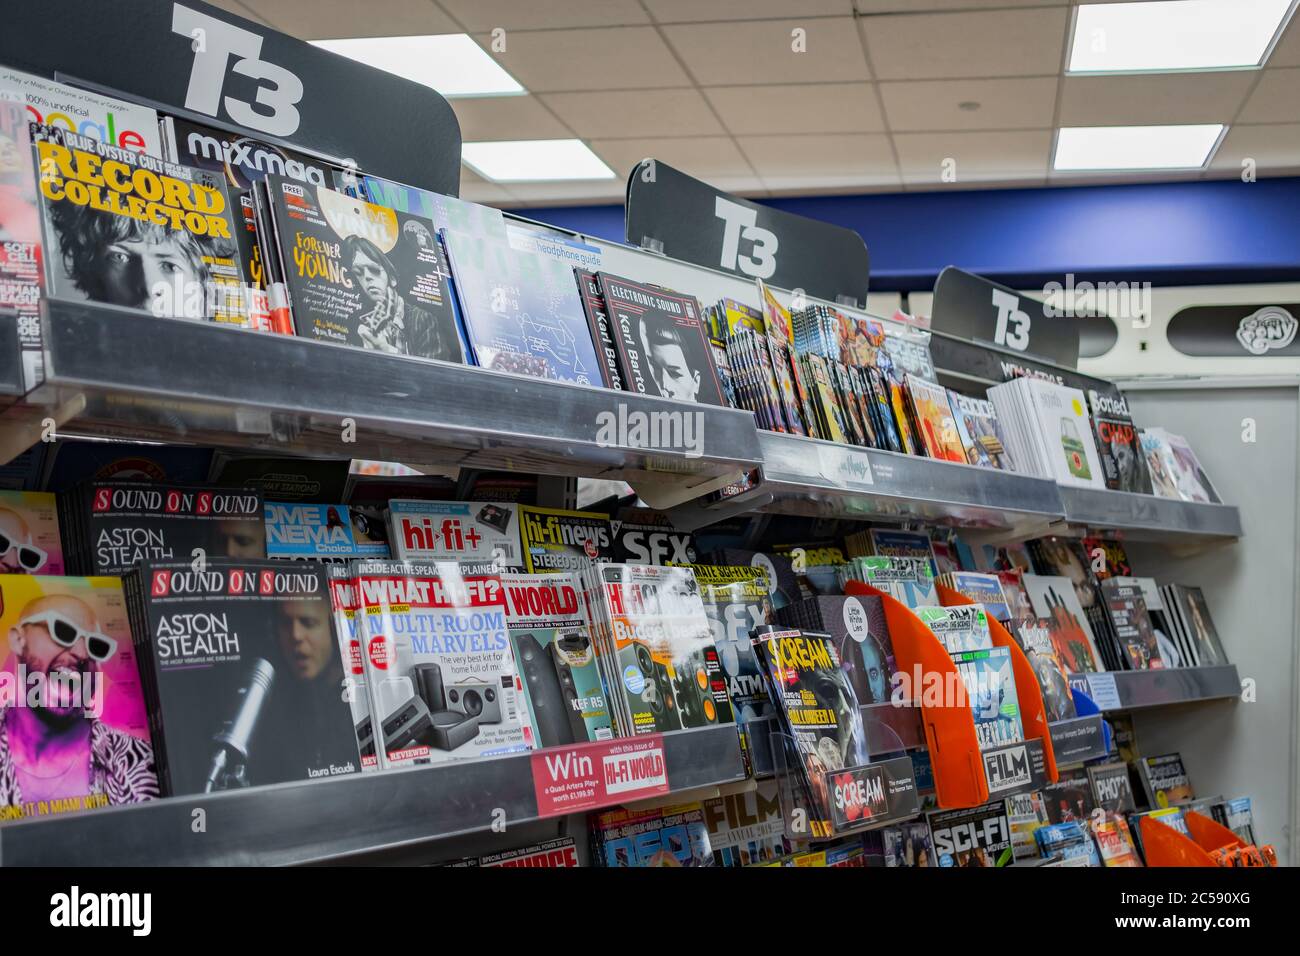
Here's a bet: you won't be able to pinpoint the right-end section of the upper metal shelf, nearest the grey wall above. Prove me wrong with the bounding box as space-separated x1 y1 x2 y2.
1061 485 1242 542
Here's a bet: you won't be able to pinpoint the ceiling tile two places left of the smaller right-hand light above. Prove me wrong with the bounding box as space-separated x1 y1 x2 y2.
736 133 898 190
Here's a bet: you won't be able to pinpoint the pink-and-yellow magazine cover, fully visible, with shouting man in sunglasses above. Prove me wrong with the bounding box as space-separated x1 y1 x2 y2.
0 575 159 822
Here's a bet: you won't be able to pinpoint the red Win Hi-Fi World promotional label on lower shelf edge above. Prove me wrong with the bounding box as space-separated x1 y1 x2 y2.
532 734 668 817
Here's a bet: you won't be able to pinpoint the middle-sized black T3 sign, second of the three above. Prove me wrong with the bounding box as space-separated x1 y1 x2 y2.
627 159 871 308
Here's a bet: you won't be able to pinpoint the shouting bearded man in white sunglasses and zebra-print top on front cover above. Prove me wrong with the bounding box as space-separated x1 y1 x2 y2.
0 594 159 806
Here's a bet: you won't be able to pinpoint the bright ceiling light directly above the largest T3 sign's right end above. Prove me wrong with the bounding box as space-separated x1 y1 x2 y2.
312 34 528 96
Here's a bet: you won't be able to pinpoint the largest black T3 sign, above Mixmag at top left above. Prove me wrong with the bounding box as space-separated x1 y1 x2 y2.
0 0 460 195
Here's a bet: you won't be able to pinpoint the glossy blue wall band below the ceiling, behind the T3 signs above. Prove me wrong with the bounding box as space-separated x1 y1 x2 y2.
520 178 1300 291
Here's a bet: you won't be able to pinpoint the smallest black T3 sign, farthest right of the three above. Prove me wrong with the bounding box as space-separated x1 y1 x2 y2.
930 265 1079 368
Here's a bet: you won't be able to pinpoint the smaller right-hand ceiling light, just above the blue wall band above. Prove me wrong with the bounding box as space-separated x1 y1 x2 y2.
1053 124 1223 170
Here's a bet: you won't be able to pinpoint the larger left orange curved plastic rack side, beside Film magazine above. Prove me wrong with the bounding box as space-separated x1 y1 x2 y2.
844 581 988 809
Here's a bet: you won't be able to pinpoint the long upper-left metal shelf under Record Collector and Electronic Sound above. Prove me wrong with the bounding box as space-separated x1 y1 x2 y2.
7 299 759 498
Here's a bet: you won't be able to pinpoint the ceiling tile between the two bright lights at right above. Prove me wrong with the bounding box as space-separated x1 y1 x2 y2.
1060 70 1258 126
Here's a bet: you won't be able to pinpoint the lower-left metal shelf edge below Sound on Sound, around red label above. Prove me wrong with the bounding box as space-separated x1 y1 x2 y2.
0 724 745 866
